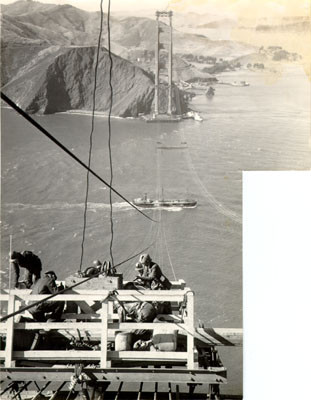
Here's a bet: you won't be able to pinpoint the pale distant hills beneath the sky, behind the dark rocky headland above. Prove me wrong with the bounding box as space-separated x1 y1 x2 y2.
2 1 254 58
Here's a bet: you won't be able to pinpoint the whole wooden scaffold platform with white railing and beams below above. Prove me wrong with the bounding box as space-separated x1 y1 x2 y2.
0 280 242 400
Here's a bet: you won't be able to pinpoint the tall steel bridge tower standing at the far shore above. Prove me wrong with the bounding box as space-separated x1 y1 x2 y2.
154 11 173 115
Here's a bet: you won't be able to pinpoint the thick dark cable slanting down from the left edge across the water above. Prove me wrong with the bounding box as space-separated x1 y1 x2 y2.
1 92 158 222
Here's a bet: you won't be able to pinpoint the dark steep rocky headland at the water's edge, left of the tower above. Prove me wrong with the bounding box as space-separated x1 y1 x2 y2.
4 47 154 117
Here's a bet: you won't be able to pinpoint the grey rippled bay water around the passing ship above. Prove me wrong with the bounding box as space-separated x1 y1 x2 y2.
1 66 311 394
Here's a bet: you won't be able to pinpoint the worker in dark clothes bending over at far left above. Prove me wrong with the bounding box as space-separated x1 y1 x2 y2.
10 251 42 289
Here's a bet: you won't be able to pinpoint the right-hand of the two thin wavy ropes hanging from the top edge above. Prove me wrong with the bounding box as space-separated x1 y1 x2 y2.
108 0 114 267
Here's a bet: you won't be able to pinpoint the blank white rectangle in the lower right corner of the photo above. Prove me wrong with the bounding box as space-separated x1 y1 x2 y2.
243 171 311 400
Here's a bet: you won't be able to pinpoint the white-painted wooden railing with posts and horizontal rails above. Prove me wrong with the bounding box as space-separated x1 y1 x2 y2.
0 284 195 369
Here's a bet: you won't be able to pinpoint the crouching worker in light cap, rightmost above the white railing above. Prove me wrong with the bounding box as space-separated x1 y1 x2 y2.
136 254 172 290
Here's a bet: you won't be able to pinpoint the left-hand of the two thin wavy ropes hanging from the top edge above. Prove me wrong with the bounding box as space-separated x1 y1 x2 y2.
79 0 105 271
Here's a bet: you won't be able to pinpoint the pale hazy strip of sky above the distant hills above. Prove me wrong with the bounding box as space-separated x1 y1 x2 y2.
0 0 310 18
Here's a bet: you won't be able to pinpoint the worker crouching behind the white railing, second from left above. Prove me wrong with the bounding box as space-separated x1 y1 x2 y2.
29 271 65 322
